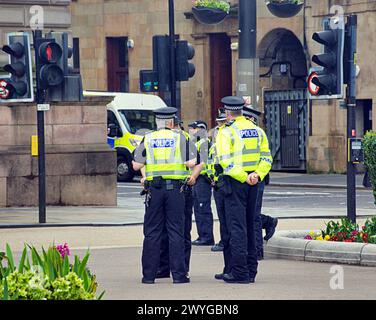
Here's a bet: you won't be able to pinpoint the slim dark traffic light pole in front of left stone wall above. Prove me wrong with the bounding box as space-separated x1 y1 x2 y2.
33 30 46 223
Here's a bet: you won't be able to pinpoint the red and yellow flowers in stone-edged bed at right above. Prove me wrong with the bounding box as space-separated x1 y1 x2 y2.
304 217 376 244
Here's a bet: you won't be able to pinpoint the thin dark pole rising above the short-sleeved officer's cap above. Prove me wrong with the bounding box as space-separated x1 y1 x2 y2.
168 0 180 114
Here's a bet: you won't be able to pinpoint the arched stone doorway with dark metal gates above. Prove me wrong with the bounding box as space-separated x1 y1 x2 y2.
258 28 308 171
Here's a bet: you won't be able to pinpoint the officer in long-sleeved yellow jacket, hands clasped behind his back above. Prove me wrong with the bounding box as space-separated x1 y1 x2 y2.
216 97 272 283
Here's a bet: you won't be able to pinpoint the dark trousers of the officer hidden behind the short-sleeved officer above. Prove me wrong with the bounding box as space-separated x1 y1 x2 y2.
159 187 193 275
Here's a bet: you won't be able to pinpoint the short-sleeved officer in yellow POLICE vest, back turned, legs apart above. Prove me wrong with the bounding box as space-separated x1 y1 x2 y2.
133 107 196 284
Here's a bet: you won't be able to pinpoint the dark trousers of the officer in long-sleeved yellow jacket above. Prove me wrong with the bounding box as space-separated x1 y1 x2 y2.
225 176 258 280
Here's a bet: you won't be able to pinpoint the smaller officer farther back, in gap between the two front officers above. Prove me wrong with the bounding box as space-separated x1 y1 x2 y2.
189 120 214 246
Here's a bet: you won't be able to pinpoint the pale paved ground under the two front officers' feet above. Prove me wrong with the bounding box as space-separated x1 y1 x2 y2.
81 247 376 300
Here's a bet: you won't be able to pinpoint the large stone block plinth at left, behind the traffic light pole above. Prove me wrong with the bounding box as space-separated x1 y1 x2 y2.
0 97 117 207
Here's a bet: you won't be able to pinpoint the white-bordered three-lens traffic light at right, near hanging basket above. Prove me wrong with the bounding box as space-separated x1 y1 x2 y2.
311 18 345 99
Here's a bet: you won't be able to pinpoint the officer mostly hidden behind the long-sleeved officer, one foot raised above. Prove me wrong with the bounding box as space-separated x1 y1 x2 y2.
243 106 278 260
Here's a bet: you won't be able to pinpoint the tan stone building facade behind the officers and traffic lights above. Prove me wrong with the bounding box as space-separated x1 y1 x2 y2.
72 0 376 172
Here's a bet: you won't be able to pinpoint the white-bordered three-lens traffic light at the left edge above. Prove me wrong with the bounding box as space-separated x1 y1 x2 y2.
0 32 34 102
